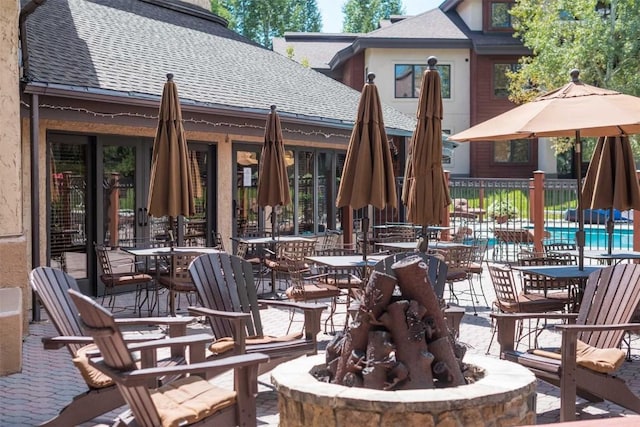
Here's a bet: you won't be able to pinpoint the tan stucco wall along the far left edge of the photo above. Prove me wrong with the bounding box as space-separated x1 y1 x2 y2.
0 0 31 332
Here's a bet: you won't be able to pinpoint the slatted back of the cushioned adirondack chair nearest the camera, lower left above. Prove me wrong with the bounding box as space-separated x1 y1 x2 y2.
69 290 162 426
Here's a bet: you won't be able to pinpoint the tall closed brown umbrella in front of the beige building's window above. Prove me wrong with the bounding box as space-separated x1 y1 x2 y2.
402 56 451 239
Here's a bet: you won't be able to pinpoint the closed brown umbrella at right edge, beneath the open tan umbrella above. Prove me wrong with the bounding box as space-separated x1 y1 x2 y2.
582 136 640 254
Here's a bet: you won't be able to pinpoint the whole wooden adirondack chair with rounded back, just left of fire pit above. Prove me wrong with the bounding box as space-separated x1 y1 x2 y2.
189 252 327 373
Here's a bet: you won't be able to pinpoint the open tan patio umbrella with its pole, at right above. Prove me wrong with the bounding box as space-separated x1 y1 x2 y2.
449 69 640 270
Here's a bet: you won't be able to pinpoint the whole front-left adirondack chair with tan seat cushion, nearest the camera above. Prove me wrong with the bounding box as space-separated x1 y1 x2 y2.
69 290 268 427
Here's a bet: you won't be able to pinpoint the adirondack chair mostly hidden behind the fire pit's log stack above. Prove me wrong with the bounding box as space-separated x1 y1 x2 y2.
373 252 465 337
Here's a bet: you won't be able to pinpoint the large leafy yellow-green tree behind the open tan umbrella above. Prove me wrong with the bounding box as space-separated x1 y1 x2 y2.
508 0 640 156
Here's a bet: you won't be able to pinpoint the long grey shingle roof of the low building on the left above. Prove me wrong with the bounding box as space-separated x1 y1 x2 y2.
22 0 415 134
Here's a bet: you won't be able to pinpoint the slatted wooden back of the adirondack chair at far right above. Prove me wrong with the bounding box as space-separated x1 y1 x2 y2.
576 264 640 348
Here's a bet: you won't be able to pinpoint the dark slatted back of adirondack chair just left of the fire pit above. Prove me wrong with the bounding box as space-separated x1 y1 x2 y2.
189 252 263 338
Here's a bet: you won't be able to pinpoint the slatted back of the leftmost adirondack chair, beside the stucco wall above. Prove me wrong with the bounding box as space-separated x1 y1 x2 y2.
29 267 85 357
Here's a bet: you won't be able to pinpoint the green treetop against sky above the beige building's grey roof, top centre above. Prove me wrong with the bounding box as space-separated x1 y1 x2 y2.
342 0 404 33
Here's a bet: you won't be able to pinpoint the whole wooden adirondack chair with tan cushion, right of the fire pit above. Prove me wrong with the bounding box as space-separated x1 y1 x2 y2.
492 264 640 421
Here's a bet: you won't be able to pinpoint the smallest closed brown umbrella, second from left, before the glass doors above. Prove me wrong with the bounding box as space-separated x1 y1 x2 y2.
258 105 291 236
